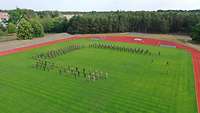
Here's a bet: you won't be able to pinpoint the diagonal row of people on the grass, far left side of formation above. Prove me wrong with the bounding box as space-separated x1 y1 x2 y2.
33 44 82 59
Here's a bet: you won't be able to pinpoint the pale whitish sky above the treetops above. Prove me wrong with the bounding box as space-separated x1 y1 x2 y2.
0 0 200 11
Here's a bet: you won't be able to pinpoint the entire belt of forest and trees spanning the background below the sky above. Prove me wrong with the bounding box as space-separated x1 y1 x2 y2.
1 8 200 41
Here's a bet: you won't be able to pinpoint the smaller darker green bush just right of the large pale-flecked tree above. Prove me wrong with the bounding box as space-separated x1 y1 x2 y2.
31 20 44 37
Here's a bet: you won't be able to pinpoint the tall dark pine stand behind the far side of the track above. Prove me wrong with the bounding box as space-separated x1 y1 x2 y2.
68 11 200 34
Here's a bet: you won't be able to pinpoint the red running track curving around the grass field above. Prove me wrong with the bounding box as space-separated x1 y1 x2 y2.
0 35 200 113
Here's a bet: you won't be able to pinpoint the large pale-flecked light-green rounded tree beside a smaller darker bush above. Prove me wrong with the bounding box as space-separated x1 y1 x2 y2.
17 18 33 40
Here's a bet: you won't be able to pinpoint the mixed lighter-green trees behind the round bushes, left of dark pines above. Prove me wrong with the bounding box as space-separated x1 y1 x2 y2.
8 8 68 33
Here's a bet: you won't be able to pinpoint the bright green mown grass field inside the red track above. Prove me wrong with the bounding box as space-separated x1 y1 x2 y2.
0 39 197 113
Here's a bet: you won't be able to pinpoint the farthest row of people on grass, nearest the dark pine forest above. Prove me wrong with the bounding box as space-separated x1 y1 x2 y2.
89 43 151 55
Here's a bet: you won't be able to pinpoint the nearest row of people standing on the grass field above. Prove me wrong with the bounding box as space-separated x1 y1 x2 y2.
34 59 108 81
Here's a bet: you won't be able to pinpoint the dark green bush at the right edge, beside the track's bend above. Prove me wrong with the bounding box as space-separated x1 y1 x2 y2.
191 23 200 42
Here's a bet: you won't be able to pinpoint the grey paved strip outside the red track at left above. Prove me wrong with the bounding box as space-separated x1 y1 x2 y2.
0 33 71 52
